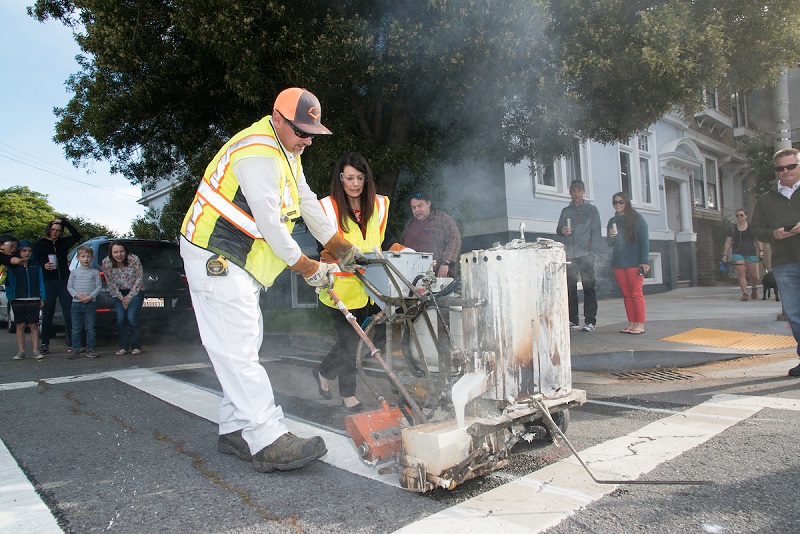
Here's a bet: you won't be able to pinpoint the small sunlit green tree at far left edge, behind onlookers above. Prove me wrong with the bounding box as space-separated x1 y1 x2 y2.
0 186 56 241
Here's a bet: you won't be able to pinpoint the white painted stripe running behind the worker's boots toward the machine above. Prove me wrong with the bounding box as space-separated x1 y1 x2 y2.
108 369 400 487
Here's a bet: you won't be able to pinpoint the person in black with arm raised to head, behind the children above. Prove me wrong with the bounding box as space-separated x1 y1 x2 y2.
33 217 81 354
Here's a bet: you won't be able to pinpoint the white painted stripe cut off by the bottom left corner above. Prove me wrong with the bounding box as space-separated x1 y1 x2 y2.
0 441 63 534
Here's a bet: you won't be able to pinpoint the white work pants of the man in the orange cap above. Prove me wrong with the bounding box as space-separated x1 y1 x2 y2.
181 238 288 454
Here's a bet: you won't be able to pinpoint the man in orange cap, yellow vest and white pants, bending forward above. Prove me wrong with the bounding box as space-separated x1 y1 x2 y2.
181 87 363 472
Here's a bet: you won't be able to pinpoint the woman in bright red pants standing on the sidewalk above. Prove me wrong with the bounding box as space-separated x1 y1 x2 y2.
606 193 650 334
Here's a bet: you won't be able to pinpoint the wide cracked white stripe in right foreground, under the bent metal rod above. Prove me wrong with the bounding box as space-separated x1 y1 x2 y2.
397 395 768 534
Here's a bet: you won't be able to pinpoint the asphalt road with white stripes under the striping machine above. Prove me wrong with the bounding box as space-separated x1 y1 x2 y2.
0 326 800 534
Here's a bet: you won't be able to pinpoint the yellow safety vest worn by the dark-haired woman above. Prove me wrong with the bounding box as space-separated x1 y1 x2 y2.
319 195 389 310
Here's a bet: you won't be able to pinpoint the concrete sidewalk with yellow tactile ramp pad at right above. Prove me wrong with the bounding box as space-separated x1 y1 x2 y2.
571 286 796 371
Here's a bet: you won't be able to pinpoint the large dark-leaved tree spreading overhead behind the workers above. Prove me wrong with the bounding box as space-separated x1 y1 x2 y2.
29 0 800 211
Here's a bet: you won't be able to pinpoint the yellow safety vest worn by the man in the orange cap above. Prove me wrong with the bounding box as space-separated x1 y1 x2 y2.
181 115 302 287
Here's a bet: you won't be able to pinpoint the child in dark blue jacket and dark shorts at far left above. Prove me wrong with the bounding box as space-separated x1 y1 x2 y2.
6 239 45 360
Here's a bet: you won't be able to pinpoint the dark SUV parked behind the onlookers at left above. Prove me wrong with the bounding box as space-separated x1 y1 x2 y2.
53 237 196 336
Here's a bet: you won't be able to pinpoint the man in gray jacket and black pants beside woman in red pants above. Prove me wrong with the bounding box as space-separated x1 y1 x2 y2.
556 180 602 332
